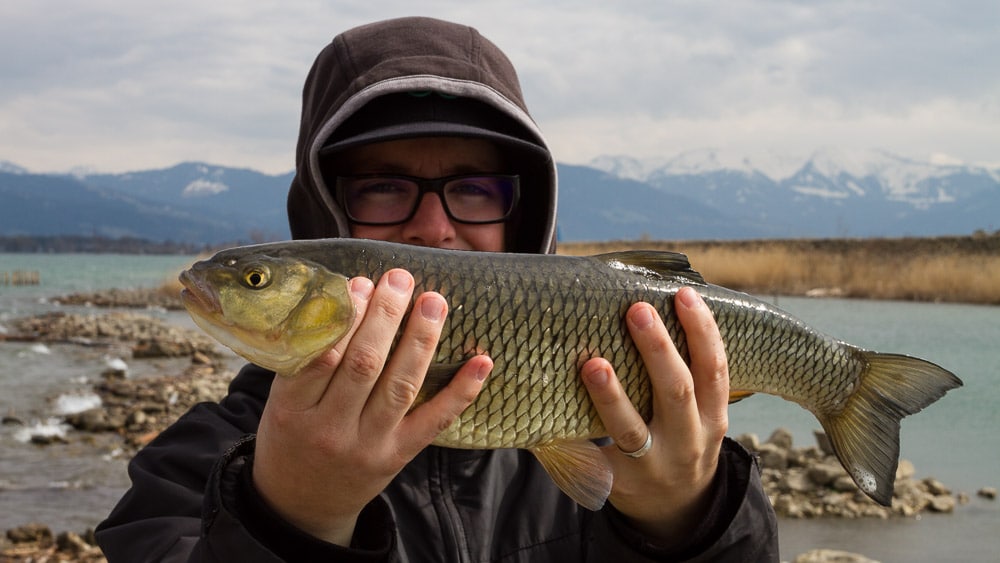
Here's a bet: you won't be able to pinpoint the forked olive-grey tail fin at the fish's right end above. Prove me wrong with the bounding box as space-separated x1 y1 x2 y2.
817 352 962 506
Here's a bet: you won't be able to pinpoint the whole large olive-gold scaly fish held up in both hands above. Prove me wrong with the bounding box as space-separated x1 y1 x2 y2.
180 239 962 510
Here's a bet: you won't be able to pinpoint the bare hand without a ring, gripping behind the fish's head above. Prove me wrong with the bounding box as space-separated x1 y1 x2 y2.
253 270 493 545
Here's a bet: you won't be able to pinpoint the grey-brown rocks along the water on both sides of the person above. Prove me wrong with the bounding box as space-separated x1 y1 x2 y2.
0 290 997 563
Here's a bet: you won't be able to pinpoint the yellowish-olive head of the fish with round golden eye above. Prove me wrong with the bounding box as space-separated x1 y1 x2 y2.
179 247 355 375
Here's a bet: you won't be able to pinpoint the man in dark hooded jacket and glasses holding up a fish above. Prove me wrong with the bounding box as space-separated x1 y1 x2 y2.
98 18 777 562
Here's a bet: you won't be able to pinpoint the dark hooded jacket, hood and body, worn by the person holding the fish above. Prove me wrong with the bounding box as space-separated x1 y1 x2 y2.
97 18 777 563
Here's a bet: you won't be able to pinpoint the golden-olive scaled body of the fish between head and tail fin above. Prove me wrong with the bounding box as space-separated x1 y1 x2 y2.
280 241 864 447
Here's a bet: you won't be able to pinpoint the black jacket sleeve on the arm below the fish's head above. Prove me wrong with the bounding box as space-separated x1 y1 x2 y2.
96 366 393 563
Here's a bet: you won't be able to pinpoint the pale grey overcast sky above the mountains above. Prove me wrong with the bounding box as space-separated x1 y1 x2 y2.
0 0 1000 173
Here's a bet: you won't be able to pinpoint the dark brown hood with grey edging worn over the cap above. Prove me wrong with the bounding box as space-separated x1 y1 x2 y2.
288 17 557 253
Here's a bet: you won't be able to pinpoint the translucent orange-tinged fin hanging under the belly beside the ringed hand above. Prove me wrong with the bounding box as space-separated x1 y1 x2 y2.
531 440 614 511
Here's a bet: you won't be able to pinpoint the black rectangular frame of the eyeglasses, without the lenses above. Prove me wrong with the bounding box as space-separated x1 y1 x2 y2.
334 173 521 227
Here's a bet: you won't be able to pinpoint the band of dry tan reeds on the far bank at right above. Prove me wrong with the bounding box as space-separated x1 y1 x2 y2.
559 235 1000 304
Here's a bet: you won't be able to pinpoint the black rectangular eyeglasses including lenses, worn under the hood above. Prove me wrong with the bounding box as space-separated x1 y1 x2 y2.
337 174 520 225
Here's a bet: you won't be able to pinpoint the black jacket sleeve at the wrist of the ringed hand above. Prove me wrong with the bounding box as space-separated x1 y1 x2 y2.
588 438 779 563
